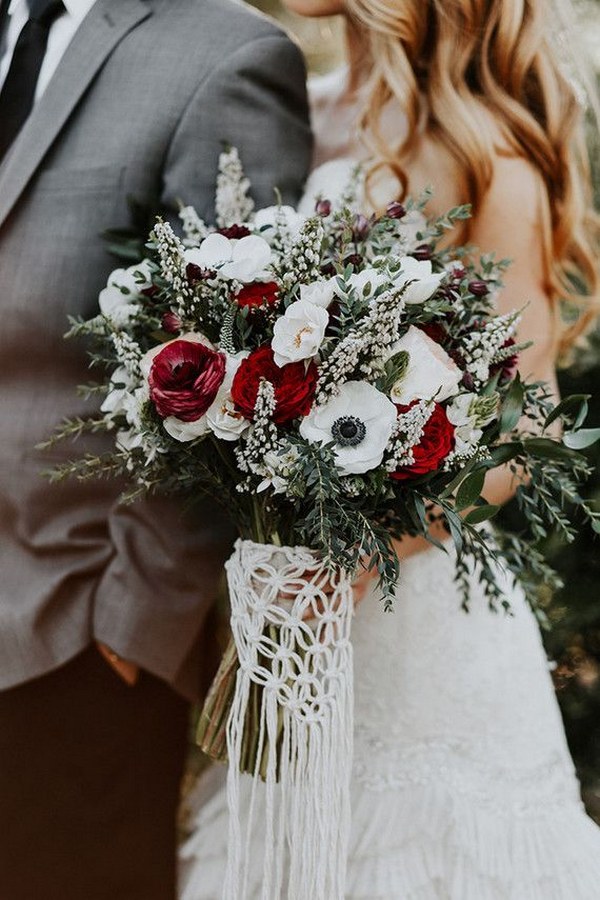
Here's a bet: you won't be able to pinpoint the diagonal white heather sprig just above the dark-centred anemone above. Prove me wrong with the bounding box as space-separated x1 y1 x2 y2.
316 287 405 403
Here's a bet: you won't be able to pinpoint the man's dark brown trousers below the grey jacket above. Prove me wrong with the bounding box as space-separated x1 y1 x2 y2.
0 647 188 900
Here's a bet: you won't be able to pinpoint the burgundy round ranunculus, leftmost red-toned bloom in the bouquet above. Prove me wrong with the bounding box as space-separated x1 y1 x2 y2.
148 340 225 422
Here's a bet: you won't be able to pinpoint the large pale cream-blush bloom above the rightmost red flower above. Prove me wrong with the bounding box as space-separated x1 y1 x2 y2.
390 325 463 406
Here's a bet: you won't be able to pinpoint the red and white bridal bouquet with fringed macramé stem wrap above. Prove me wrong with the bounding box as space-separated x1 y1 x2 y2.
47 150 600 897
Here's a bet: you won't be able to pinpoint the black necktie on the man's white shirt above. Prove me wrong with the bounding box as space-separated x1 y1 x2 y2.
0 0 65 160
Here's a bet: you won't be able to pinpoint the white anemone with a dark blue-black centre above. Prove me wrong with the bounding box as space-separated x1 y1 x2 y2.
300 381 397 475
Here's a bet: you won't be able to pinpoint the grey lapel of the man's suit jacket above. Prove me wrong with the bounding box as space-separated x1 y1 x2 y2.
0 0 152 225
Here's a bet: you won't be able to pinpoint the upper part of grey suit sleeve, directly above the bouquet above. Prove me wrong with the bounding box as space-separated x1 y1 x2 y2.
162 30 312 221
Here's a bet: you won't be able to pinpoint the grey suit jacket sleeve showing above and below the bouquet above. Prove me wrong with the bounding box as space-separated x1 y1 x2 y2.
93 29 312 682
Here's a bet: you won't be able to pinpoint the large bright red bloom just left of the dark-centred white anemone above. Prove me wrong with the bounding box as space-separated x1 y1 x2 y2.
231 345 317 425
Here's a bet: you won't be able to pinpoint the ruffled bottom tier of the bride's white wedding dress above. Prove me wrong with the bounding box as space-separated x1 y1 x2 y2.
180 773 600 900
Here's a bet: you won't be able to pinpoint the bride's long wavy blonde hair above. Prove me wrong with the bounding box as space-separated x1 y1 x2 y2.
346 0 600 350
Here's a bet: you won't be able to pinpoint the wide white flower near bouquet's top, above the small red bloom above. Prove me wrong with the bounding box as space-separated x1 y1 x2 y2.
184 234 273 284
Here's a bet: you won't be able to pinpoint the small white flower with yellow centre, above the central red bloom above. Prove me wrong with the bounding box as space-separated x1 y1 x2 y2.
271 300 329 366
